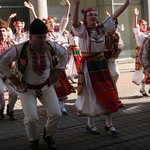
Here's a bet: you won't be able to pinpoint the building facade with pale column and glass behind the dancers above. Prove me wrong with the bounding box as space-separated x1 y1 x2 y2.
0 0 150 58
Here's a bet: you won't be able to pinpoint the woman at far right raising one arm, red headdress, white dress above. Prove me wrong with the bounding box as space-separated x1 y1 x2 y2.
132 8 150 96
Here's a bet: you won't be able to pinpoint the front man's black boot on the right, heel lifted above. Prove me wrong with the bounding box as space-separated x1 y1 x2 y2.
43 128 57 150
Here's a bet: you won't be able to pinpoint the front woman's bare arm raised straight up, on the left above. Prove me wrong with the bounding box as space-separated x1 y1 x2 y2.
72 0 80 28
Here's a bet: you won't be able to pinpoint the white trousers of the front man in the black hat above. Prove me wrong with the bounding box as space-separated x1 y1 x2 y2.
19 85 62 141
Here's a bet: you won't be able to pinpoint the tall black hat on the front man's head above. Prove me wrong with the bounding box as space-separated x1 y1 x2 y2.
29 19 47 34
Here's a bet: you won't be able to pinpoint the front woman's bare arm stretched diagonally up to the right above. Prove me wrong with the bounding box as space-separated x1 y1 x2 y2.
111 0 131 20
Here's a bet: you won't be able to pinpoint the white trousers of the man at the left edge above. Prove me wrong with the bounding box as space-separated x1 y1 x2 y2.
0 77 18 112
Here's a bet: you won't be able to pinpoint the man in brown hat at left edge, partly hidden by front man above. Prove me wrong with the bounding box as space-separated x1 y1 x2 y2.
0 19 18 120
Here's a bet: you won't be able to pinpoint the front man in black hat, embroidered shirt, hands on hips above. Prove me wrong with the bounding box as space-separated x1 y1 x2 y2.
0 19 68 150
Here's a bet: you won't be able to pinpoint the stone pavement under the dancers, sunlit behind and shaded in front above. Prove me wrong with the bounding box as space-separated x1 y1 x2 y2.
0 62 150 150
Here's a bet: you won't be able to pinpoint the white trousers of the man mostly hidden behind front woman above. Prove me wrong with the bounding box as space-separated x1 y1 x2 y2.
107 59 120 83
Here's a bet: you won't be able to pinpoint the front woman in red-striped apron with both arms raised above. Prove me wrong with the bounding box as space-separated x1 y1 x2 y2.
72 0 130 134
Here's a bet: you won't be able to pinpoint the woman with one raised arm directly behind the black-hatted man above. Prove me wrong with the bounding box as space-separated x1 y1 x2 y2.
43 0 75 115
